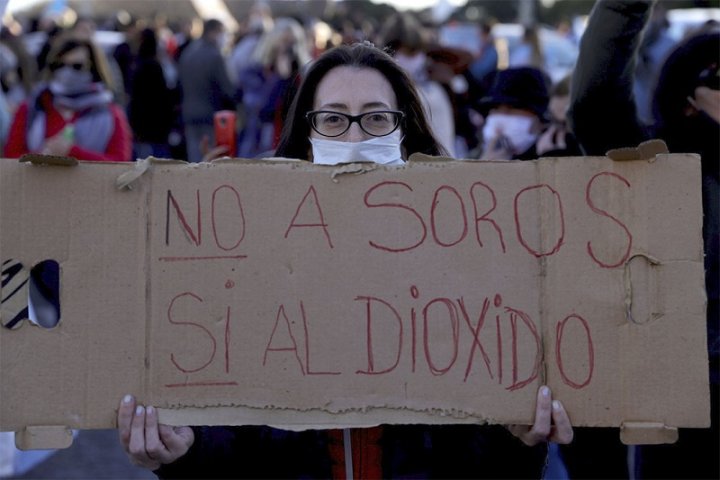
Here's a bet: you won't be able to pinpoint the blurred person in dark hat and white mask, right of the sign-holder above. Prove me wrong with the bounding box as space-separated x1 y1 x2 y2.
480 67 550 160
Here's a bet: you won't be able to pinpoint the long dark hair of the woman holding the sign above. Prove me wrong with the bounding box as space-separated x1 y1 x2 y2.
275 42 447 160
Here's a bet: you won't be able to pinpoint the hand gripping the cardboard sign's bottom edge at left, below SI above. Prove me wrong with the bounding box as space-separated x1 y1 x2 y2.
118 395 195 470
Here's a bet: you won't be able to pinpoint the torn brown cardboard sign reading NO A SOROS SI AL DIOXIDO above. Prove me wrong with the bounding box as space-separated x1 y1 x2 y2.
0 155 709 448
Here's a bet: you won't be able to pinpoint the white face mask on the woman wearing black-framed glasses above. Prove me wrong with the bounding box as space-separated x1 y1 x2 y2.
310 130 405 165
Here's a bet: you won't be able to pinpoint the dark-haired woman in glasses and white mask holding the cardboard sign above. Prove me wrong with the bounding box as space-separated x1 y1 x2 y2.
118 44 573 478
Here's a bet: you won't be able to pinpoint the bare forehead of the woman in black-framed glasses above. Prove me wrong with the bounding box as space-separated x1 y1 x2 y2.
313 66 397 112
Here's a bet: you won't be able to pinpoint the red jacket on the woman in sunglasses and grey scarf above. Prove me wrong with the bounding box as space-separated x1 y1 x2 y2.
4 94 132 162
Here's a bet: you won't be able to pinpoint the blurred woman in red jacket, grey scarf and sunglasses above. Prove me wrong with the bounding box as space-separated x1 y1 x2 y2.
4 36 132 161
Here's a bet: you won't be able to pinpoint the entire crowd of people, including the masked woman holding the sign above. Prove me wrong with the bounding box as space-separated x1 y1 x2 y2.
0 0 720 478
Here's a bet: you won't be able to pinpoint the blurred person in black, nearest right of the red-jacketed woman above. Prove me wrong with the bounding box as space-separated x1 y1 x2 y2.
128 28 175 158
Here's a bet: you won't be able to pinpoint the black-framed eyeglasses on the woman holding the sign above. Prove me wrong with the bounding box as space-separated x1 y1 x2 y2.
305 110 405 137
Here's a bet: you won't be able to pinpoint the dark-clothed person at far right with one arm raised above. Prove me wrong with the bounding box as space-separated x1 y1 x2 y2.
566 0 720 478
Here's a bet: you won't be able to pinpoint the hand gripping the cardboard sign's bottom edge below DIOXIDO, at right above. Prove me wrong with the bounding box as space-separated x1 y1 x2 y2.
507 385 573 447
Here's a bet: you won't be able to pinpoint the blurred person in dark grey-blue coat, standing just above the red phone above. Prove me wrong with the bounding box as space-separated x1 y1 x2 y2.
178 19 239 162
